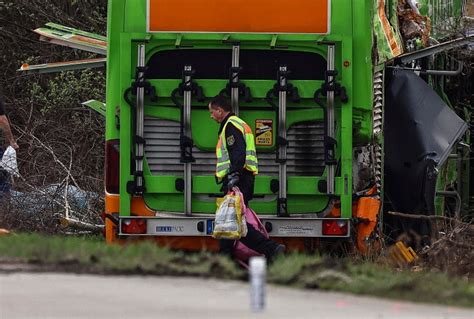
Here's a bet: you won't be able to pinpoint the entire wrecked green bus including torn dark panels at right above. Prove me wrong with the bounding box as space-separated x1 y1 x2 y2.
97 0 469 252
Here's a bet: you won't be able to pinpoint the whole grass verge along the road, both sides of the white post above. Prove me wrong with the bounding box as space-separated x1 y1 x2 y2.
0 234 474 307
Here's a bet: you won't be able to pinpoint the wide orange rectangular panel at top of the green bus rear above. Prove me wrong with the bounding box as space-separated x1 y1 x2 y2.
148 0 329 33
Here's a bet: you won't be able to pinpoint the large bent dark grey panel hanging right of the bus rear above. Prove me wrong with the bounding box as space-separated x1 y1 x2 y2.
384 70 468 213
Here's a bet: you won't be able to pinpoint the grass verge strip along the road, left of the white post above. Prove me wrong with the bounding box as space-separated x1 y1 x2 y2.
0 234 245 279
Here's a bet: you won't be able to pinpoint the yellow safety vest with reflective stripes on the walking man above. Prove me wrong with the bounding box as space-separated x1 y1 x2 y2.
216 115 258 180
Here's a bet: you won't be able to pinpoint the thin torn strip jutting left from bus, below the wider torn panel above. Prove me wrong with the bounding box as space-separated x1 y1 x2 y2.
17 58 107 74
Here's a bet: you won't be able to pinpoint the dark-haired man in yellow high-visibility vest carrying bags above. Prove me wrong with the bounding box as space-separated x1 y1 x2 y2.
209 95 285 259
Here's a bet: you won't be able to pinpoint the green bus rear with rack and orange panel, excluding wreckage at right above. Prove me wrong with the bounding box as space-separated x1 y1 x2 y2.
105 0 381 255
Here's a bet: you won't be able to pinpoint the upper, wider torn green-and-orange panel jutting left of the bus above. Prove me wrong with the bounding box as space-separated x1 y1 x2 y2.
33 24 107 55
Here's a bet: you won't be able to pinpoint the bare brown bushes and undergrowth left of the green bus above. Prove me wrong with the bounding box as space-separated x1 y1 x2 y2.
0 0 107 222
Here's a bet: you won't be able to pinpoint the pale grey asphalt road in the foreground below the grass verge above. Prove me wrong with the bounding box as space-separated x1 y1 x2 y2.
0 273 474 319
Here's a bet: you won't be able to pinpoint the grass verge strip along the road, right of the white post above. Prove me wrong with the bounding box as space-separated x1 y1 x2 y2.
269 254 474 307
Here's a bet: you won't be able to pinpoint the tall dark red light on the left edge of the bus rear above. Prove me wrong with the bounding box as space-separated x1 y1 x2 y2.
105 140 120 194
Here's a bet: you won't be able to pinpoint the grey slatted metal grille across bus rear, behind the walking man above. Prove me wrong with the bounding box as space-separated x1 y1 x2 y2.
144 117 325 176
